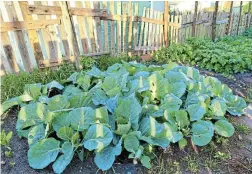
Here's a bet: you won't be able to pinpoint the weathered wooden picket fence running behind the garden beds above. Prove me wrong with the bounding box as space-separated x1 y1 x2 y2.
0 1 251 75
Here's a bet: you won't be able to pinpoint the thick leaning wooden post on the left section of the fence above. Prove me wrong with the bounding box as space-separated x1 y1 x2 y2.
59 1 82 69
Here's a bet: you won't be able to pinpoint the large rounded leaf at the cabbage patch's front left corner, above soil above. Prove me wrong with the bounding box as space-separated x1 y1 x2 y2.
28 138 60 169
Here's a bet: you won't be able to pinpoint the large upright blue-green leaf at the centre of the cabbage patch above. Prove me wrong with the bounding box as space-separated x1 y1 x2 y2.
115 95 142 130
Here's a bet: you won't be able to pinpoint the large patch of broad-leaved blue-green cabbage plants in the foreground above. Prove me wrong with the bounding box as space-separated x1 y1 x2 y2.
0 61 246 173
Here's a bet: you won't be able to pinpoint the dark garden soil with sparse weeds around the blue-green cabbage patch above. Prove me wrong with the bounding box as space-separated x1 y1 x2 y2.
1 71 252 174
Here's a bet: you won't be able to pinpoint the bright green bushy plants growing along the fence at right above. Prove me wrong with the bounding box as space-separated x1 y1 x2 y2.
153 28 252 75
